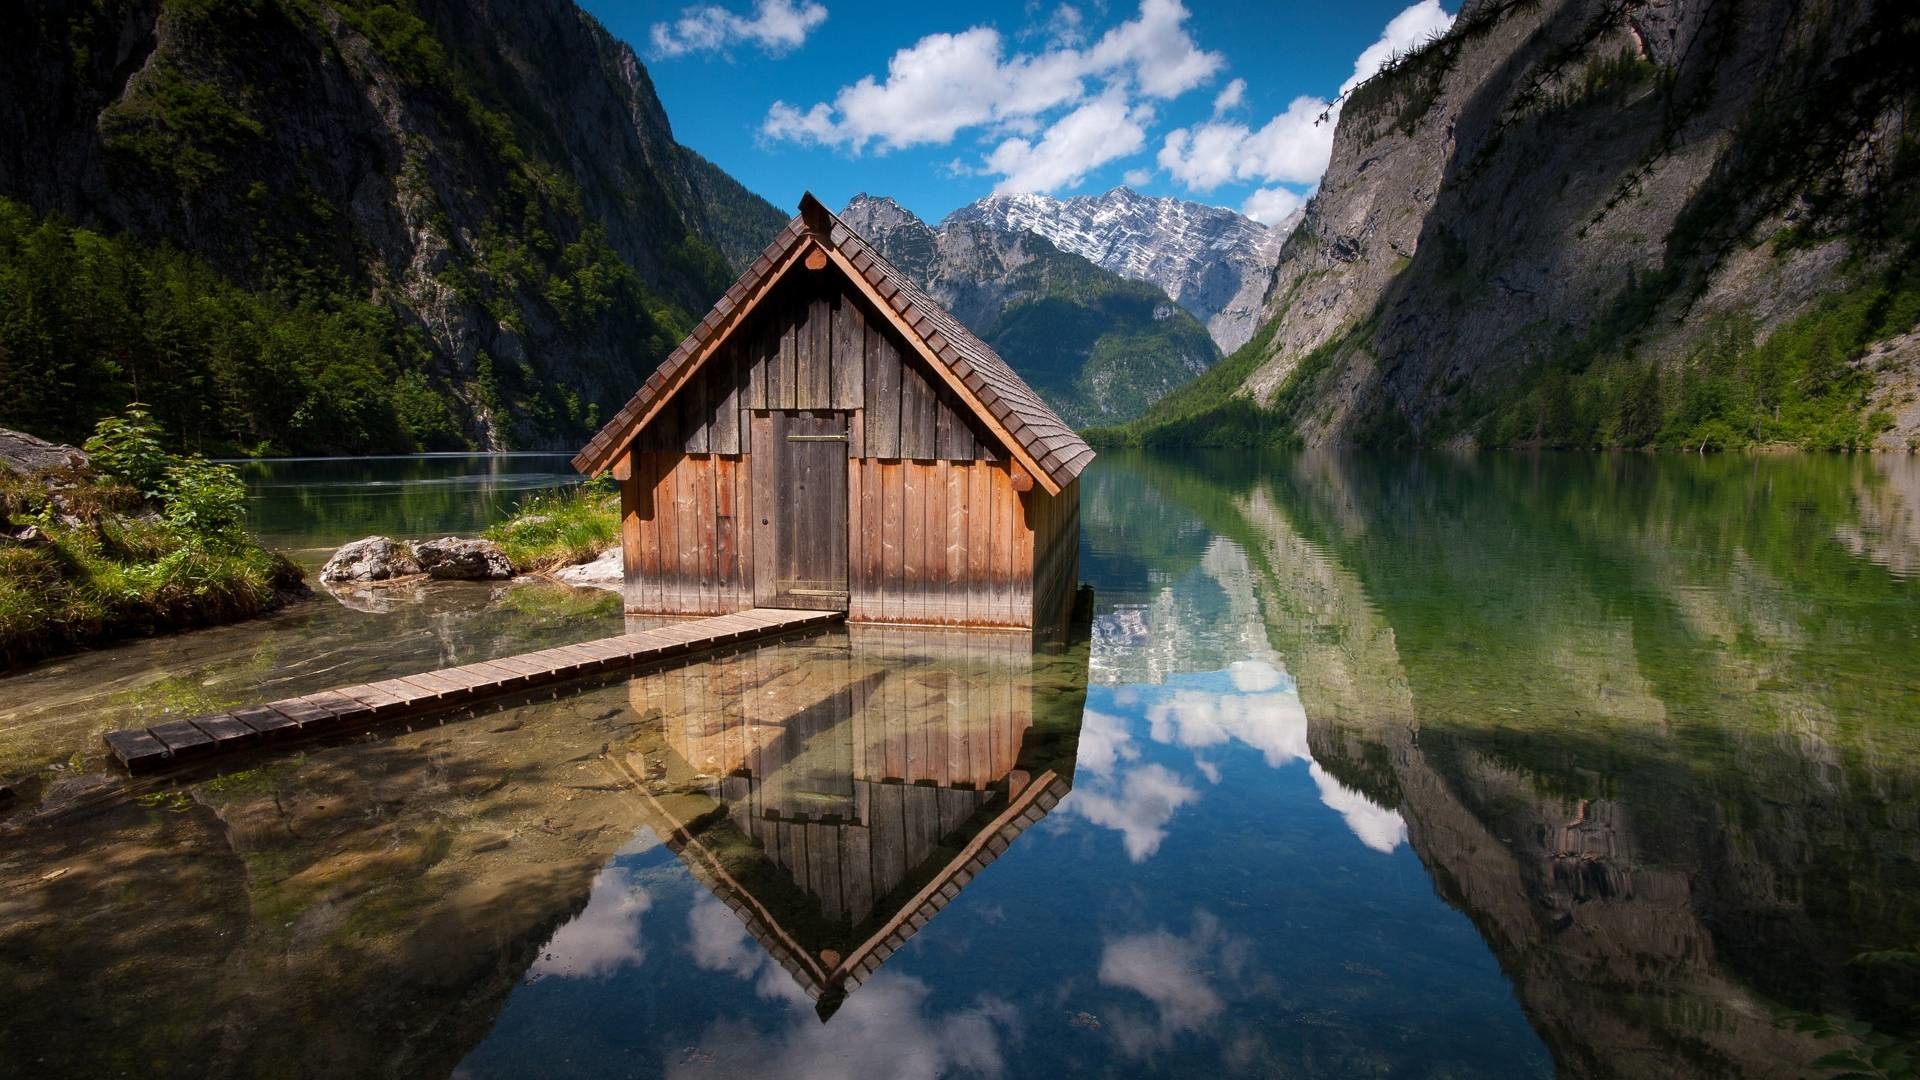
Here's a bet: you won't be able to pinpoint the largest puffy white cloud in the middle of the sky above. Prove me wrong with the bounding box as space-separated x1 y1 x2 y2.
760 0 1225 171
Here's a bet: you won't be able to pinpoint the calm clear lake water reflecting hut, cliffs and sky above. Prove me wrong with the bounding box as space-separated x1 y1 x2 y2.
0 454 1920 1078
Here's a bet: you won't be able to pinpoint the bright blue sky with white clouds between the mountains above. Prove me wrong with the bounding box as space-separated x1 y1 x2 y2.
584 0 1457 221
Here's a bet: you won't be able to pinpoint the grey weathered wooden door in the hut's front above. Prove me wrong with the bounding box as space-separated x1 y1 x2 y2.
755 411 847 611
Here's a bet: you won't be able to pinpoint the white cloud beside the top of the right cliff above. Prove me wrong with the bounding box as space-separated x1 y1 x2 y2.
1158 0 1453 191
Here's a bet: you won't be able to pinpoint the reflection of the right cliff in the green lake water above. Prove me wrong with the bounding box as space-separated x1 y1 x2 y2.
1083 447 1920 1076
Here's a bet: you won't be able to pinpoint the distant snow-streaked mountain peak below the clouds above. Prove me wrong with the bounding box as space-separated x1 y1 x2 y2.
943 188 1300 352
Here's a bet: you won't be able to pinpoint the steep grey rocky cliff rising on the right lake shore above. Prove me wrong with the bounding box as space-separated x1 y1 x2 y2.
1128 0 1920 448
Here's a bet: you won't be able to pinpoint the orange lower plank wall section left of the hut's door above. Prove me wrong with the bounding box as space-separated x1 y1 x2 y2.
620 450 756 615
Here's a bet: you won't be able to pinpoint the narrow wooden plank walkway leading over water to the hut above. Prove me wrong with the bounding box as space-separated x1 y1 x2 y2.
106 607 845 773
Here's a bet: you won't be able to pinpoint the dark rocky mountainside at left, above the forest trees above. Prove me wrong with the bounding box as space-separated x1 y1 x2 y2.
0 0 785 448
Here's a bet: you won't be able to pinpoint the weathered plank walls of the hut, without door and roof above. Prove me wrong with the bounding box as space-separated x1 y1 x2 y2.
622 265 1079 626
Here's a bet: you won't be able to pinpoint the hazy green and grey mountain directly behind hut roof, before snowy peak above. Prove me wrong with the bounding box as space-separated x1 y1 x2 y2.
841 196 1219 427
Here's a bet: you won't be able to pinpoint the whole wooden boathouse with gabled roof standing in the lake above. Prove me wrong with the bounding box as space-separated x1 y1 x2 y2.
574 194 1092 628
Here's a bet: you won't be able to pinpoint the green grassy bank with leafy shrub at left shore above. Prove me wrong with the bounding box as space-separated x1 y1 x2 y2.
0 409 303 671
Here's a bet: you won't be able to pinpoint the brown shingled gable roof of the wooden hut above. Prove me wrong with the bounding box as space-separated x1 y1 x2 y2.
574 194 1092 492
